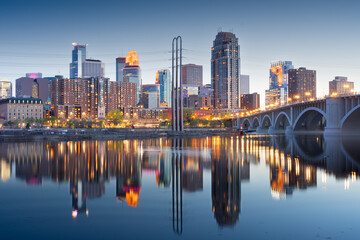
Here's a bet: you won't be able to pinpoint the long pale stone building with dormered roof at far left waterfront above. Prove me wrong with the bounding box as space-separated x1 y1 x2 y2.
0 98 44 121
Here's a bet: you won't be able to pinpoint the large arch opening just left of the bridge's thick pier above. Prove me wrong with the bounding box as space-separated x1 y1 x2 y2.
293 107 327 131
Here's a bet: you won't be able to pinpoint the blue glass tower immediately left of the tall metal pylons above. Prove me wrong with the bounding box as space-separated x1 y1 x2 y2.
155 69 172 108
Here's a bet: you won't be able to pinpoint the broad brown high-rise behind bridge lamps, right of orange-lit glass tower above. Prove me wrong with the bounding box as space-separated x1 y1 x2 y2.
288 67 316 102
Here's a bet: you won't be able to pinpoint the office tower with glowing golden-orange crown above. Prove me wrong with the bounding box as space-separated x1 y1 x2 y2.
123 51 142 103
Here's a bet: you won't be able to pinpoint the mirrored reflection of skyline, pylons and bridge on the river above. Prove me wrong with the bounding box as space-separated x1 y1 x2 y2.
0 135 360 231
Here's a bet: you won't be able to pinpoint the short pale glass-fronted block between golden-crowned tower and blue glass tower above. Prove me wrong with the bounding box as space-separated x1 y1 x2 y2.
140 84 160 109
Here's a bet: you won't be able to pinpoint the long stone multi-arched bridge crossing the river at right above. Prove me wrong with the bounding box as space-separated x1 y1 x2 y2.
236 94 360 135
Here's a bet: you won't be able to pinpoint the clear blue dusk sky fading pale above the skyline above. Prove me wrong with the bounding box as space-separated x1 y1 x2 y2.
0 0 360 106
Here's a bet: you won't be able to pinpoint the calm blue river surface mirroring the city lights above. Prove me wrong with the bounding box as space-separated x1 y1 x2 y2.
0 135 360 239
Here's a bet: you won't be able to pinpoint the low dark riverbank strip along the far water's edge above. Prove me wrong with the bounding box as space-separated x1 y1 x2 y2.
0 128 239 142
